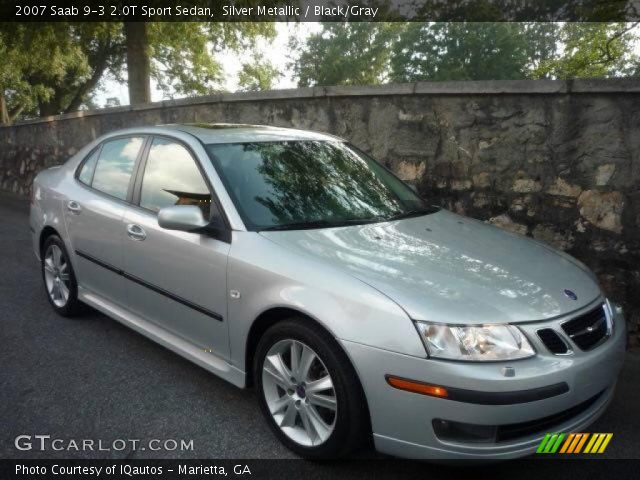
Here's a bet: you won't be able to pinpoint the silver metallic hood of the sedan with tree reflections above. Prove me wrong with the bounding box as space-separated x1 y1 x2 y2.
261 210 600 324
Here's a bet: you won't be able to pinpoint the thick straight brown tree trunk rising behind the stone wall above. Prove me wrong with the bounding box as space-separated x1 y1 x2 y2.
124 22 151 105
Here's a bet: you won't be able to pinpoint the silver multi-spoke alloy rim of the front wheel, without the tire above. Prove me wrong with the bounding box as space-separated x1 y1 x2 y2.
262 339 338 447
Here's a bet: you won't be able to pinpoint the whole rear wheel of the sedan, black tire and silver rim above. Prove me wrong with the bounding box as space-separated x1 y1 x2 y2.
40 234 84 317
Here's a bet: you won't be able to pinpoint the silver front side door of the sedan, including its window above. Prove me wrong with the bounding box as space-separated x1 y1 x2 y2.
124 136 230 359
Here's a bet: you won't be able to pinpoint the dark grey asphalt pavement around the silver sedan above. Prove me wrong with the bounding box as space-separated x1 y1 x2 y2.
0 194 640 459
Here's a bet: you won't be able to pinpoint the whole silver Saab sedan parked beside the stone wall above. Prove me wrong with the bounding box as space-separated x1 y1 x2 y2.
30 124 625 459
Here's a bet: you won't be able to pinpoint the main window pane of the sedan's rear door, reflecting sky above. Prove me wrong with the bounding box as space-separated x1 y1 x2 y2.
91 137 144 200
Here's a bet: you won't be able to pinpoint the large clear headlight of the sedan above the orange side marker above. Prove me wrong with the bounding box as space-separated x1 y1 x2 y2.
415 321 535 362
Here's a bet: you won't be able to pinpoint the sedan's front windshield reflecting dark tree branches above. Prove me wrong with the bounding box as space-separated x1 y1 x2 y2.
207 140 434 230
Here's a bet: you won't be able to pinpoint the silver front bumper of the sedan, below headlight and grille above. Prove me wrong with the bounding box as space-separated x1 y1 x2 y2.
342 304 626 460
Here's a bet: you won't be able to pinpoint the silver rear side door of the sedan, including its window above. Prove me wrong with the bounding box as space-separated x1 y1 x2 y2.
63 135 147 304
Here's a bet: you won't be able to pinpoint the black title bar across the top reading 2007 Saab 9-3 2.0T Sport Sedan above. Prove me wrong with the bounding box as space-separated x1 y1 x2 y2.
0 0 640 22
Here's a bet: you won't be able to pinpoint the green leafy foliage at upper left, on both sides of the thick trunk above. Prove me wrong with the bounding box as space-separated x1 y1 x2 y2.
0 22 275 122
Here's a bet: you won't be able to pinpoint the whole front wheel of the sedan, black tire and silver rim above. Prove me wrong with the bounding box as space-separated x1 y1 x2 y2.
253 318 368 458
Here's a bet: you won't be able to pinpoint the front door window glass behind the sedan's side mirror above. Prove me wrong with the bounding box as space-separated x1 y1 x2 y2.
140 138 211 219
